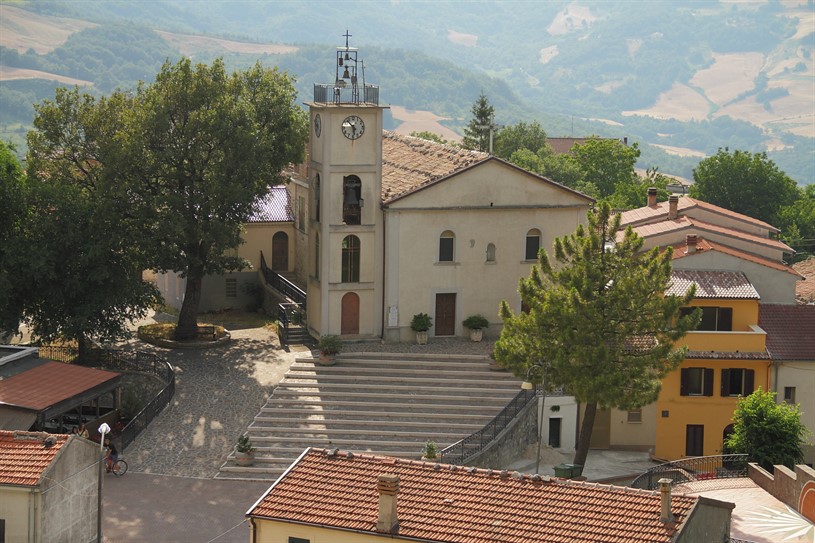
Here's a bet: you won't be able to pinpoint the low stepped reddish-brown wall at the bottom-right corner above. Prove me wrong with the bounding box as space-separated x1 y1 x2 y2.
747 463 815 522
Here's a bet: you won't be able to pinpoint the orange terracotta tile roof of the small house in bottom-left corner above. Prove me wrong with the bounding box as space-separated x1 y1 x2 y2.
0 430 69 486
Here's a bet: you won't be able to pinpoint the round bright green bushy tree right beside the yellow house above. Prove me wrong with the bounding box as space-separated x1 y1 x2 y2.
725 388 810 473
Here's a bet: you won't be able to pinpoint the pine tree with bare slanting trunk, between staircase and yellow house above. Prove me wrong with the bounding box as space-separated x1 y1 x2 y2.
495 203 698 465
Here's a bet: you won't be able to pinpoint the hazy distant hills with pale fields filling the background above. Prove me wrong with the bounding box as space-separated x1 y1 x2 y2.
0 0 815 184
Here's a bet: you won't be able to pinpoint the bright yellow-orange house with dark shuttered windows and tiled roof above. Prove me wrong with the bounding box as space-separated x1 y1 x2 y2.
654 270 772 460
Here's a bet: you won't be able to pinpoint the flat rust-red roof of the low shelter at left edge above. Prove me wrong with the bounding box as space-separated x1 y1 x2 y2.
0 362 120 411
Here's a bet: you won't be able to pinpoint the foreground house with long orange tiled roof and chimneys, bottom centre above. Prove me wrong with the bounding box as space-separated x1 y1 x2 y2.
247 448 733 543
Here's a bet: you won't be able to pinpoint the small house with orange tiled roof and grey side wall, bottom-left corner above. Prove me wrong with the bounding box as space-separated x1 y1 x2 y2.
0 430 99 543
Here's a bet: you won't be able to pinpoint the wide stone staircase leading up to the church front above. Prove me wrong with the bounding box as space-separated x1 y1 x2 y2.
217 353 520 480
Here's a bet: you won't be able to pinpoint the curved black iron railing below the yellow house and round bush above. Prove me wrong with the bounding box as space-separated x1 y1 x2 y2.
630 454 749 490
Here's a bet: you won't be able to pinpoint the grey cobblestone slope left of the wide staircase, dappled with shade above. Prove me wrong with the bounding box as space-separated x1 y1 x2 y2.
123 328 308 478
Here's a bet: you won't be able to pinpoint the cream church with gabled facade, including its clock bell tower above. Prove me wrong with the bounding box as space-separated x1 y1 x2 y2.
159 37 594 342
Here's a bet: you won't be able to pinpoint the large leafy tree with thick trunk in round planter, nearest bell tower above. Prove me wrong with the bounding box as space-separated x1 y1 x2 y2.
32 59 307 339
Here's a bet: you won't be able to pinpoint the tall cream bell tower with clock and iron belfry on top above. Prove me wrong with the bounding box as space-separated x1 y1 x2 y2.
306 31 387 338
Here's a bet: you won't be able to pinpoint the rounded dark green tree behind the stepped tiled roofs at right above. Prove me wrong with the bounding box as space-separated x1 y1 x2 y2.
690 147 799 224
